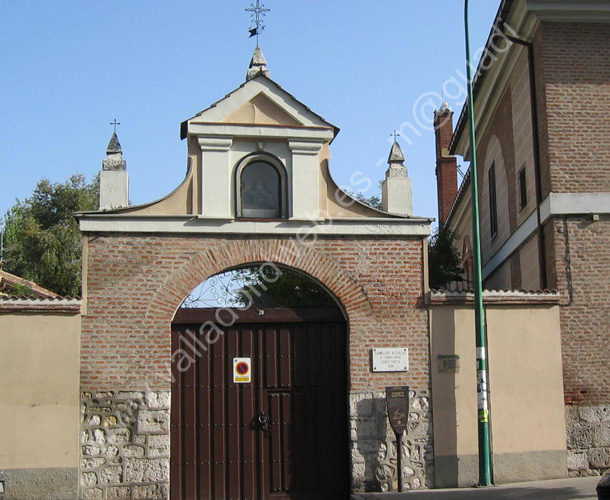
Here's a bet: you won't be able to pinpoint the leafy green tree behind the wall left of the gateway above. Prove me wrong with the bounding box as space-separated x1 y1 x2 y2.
3 174 99 296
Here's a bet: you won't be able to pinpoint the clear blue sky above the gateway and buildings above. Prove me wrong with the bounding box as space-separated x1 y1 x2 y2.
0 0 499 223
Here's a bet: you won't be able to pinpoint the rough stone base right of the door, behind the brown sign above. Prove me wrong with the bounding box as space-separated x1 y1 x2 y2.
350 390 434 492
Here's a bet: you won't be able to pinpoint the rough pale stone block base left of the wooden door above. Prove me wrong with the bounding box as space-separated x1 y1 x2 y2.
80 391 170 500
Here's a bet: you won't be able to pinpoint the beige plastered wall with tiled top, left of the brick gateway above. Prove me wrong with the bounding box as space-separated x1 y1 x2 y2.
0 297 81 500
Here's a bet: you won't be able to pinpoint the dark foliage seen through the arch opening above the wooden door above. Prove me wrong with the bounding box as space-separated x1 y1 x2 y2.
235 265 337 309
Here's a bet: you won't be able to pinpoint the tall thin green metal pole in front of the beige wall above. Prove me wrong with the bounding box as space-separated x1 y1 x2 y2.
464 0 491 486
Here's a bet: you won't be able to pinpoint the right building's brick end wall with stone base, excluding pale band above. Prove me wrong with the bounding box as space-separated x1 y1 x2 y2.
534 23 610 475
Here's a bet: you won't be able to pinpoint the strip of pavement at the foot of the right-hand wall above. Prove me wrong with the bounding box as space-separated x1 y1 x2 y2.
352 477 601 500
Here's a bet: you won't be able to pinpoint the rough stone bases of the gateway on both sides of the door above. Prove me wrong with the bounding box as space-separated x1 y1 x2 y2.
79 391 434 500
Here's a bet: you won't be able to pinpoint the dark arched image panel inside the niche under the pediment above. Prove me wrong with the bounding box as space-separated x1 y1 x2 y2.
241 162 281 219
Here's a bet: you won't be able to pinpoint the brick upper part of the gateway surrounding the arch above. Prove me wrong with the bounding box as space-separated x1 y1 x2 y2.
81 234 430 391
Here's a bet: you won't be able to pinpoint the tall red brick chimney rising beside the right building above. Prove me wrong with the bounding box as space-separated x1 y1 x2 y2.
434 102 458 226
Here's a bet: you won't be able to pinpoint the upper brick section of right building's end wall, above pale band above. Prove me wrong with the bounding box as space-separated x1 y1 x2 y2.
538 23 610 193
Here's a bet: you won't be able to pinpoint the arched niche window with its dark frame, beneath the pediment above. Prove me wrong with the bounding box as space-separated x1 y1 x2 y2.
236 156 285 219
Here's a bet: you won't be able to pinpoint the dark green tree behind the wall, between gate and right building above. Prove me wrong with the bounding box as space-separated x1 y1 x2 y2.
428 226 464 290
